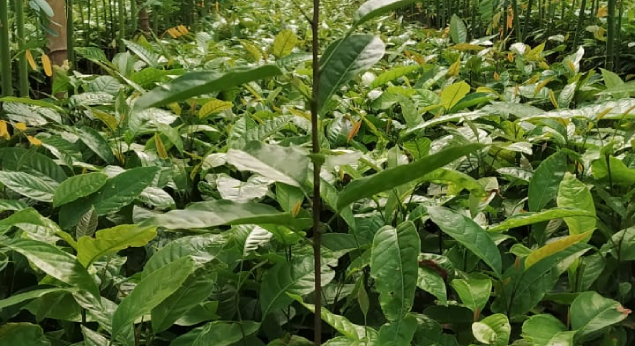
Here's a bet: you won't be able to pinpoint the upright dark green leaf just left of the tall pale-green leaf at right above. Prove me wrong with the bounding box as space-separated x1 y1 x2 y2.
528 151 567 211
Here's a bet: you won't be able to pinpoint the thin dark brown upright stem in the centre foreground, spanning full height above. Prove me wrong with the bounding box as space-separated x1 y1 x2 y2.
311 0 322 346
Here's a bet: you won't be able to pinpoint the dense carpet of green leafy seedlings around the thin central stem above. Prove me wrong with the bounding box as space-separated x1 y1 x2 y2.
0 0 635 346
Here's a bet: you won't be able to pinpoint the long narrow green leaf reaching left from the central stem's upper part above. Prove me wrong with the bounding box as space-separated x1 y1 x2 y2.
134 65 282 111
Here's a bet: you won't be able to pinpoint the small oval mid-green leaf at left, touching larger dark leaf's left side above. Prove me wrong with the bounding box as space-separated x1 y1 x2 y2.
53 173 108 207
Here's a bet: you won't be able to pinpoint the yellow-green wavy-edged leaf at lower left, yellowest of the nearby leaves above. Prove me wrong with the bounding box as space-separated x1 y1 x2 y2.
77 225 157 267
